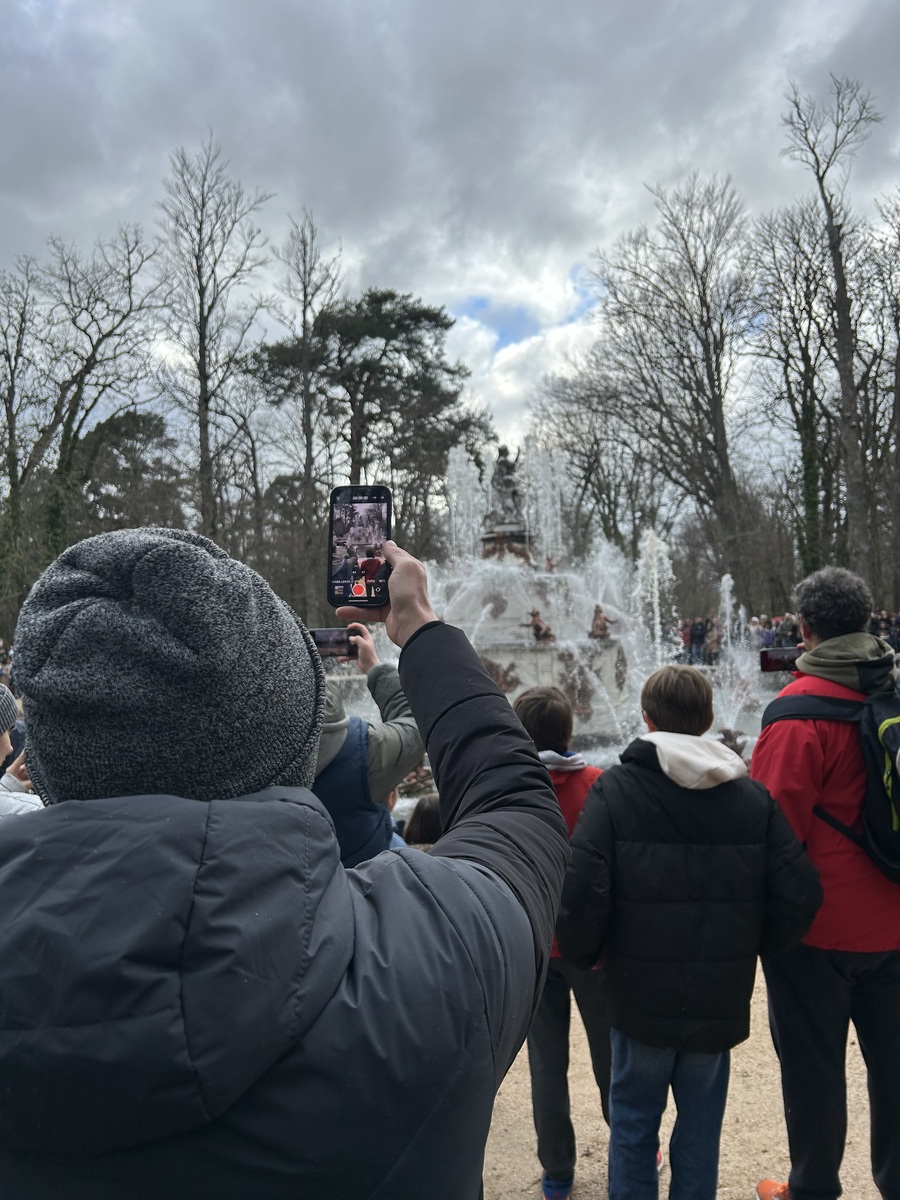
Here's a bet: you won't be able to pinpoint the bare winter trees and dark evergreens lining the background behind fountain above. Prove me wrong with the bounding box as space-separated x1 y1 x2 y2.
0 77 900 638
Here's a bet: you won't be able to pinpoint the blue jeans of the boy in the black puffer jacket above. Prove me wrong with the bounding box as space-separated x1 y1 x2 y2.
610 1030 731 1200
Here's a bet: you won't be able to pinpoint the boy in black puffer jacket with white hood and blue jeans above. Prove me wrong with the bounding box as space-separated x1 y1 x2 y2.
557 666 822 1200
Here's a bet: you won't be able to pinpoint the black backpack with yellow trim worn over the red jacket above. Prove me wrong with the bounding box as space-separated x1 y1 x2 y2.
762 688 900 883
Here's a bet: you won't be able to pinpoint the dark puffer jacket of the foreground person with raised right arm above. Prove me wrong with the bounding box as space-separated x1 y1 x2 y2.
0 625 568 1200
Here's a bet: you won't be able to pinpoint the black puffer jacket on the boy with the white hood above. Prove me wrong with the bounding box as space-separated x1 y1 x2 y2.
557 734 822 1054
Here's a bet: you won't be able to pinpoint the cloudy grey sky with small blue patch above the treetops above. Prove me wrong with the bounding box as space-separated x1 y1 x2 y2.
0 0 900 442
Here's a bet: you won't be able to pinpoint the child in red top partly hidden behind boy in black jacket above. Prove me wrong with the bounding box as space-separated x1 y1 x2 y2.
512 688 611 1200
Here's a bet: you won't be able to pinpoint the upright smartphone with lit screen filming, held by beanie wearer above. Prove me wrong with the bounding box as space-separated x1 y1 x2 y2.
325 484 391 608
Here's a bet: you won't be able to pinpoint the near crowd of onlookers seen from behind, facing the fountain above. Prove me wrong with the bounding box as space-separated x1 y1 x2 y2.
0 529 900 1200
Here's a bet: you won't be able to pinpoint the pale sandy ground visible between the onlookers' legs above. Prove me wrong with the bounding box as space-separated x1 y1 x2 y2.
485 973 878 1200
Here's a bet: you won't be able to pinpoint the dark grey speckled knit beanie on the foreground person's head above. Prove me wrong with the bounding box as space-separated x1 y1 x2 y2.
13 529 325 804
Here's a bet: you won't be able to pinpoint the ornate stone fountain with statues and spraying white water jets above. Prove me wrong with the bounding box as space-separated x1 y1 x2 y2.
330 442 784 764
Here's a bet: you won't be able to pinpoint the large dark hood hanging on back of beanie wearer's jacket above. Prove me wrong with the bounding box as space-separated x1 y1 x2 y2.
0 788 354 1153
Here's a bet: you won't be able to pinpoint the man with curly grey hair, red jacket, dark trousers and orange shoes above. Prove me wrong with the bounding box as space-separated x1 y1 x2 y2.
751 568 900 1200
